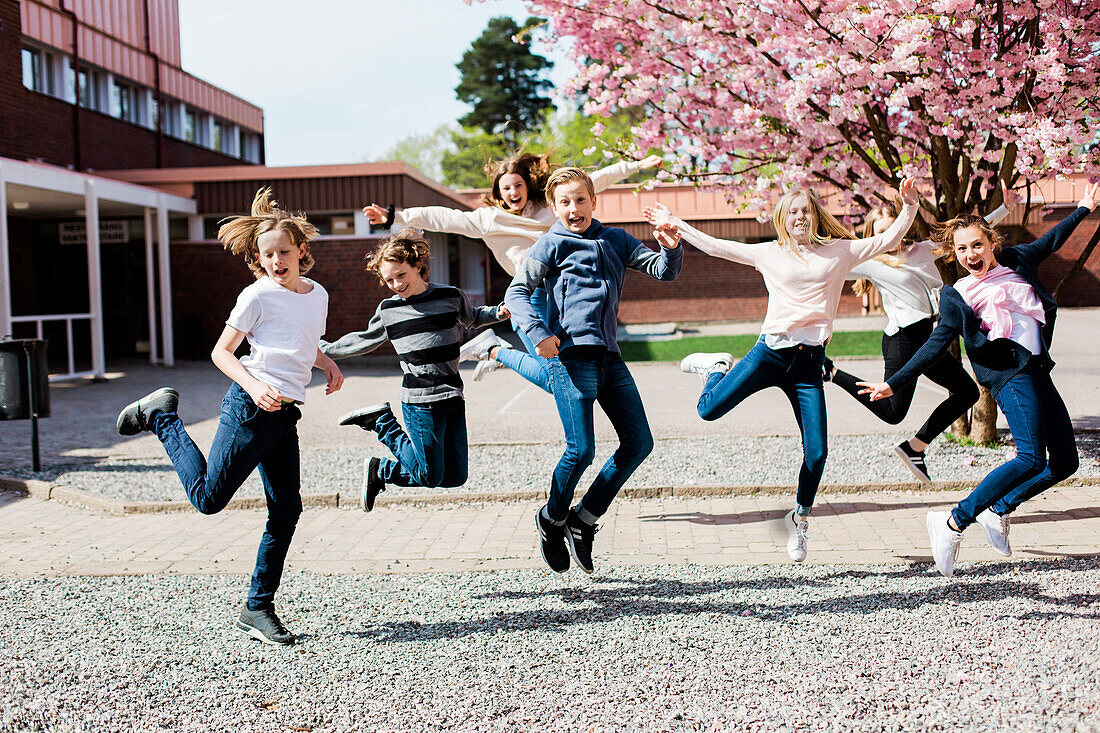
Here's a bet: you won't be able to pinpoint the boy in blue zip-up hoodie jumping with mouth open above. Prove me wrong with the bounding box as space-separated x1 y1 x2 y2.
505 168 683 572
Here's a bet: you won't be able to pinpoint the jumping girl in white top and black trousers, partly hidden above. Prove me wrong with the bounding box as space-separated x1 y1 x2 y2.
824 183 1013 483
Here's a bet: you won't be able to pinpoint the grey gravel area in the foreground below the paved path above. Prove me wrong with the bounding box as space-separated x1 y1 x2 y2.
0 558 1100 732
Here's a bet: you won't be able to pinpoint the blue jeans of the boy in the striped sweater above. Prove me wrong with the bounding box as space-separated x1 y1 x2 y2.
374 397 469 489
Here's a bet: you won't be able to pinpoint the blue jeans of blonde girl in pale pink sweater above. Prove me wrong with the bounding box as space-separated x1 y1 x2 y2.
699 336 828 516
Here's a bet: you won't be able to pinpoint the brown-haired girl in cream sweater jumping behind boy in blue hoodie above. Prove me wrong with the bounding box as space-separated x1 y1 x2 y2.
363 148 661 392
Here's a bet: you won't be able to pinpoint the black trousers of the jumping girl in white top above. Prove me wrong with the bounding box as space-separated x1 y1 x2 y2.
833 318 978 442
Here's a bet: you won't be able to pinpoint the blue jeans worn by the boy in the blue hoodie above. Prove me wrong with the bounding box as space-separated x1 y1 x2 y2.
546 347 653 524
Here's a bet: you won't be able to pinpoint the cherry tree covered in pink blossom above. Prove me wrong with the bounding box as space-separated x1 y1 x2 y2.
508 0 1100 441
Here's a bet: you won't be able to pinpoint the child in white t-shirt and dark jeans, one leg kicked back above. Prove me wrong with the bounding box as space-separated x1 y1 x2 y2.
117 188 343 645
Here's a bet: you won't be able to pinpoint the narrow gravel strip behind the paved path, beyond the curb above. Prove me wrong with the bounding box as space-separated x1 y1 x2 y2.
6 433 1100 501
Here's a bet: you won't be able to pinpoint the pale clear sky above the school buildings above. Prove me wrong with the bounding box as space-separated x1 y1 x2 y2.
179 0 572 165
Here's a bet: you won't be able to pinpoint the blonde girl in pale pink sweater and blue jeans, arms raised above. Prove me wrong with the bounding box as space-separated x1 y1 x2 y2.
644 178 917 562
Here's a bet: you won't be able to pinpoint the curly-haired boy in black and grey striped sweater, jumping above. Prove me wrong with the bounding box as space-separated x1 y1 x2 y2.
321 228 509 512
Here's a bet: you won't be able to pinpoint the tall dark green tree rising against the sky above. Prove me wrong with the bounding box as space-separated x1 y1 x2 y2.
454 17 553 144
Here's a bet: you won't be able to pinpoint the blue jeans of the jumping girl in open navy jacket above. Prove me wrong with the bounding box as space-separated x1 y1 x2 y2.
952 359 1078 529
